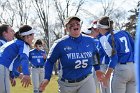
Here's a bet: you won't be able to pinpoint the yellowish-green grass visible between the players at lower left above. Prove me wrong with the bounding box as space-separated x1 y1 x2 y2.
11 75 58 93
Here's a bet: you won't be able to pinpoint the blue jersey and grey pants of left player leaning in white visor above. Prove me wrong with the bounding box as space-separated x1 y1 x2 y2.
0 39 30 93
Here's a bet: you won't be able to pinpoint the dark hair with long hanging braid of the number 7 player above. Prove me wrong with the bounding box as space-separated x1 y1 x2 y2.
99 16 116 56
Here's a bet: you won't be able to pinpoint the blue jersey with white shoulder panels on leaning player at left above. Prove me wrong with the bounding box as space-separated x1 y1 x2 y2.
0 40 30 75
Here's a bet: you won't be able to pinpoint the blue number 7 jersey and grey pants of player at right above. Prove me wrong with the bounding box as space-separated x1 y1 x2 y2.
100 30 136 93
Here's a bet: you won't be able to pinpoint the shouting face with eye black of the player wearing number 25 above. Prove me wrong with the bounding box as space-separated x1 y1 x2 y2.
66 19 81 37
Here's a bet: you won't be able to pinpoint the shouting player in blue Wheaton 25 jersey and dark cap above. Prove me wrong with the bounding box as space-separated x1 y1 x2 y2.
40 17 103 93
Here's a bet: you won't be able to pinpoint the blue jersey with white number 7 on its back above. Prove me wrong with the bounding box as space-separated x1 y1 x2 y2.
102 30 134 68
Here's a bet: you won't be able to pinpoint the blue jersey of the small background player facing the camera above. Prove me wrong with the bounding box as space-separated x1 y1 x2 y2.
29 49 46 67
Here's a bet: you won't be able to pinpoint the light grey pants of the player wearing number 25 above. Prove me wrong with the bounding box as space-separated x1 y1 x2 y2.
58 74 96 93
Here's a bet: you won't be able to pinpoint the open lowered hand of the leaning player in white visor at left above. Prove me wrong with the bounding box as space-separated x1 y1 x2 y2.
21 75 31 88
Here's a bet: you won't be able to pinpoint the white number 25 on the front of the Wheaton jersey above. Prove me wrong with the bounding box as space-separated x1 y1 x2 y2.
75 59 88 69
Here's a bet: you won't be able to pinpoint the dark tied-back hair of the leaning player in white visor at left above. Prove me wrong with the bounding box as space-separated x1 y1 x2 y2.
15 25 32 40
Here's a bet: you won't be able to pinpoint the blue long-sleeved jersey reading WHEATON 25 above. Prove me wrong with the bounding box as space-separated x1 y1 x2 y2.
45 35 99 80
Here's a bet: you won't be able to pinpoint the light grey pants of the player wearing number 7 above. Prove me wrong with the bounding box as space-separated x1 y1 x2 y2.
111 62 136 93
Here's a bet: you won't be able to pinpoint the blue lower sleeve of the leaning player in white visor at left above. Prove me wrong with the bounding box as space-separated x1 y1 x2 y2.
20 53 30 75
